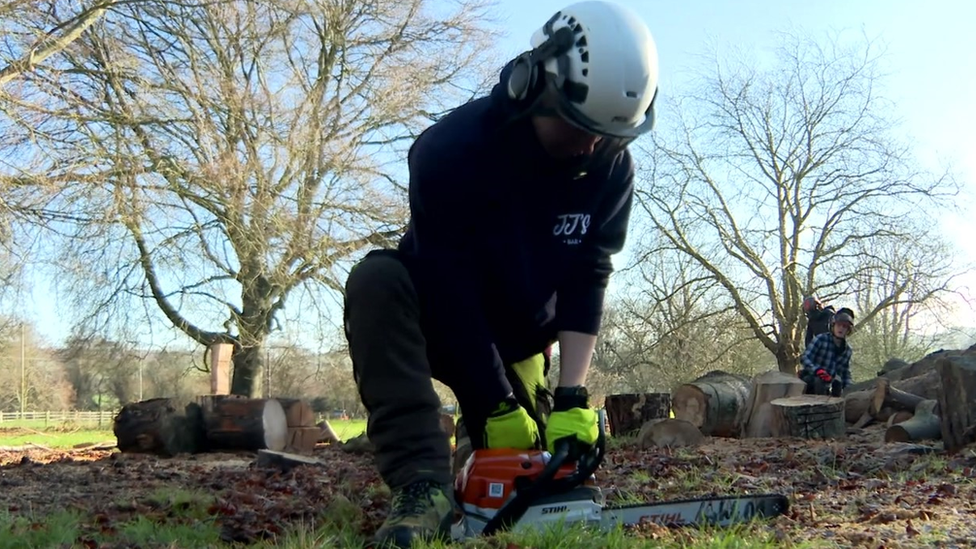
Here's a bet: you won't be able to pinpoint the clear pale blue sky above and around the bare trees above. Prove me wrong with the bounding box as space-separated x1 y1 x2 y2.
25 0 976 343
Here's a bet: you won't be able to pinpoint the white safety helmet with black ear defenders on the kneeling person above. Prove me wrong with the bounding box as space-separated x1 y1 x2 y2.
508 0 658 141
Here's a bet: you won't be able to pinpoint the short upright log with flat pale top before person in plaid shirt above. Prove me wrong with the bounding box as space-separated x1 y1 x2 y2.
770 395 847 439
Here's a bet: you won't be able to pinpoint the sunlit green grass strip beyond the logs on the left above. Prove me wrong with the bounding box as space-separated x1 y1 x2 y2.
0 419 366 448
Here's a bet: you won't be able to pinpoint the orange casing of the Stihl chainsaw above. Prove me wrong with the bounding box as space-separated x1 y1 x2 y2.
454 448 596 516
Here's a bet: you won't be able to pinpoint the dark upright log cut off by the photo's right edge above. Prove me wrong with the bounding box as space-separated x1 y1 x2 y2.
936 356 976 454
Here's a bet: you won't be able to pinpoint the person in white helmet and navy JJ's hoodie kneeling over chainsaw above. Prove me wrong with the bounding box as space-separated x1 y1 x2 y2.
344 1 658 547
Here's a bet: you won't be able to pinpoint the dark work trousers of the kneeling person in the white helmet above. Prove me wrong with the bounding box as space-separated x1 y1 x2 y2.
343 250 544 489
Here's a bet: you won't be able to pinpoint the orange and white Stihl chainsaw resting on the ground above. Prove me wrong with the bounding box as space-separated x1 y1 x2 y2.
451 410 789 541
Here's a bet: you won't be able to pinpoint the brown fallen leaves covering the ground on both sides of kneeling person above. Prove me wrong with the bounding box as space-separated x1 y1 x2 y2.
0 424 976 548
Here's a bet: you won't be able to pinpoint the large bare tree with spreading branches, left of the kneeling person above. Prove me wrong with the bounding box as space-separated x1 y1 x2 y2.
3 0 500 395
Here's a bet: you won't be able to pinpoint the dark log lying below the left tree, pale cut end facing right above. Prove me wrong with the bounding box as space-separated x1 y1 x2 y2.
203 398 288 451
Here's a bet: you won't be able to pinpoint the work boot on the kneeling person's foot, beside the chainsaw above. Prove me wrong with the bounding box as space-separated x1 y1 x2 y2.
371 480 460 549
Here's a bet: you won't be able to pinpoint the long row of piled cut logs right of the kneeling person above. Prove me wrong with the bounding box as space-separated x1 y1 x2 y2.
607 345 976 453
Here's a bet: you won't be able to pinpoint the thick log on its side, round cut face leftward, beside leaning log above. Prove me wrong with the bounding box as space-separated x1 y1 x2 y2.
671 370 752 437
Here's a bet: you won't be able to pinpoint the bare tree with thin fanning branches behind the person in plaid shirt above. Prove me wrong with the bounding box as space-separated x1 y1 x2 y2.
638 28 958 372
